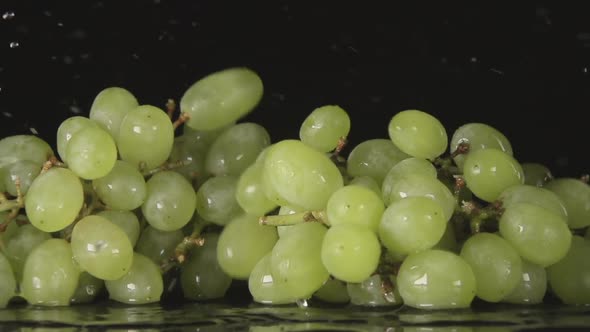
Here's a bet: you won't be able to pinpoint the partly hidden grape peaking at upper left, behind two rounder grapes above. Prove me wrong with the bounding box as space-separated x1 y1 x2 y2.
89 87 139 139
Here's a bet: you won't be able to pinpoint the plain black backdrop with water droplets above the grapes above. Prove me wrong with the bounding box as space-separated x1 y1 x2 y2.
0 0 590 176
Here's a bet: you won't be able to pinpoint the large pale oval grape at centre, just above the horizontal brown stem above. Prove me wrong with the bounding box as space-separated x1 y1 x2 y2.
263 140 344 210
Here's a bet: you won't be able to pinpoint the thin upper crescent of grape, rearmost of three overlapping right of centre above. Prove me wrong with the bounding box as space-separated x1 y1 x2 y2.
380 157 437 205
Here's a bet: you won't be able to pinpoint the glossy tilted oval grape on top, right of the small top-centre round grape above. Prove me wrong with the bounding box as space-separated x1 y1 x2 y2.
388 110 448 160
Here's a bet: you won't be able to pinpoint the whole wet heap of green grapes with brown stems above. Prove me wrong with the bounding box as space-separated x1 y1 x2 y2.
0 68 590 309
